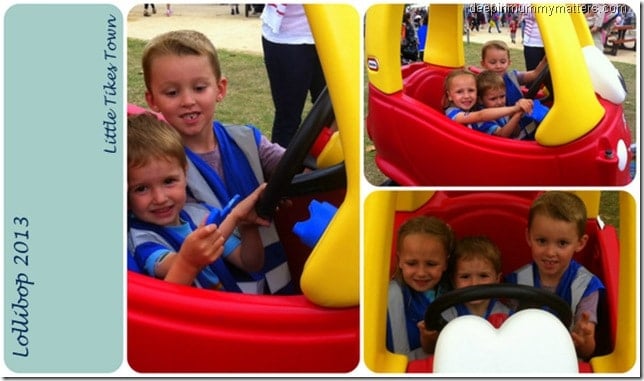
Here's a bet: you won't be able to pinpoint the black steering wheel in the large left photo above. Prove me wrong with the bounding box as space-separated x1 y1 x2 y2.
255 88 347 220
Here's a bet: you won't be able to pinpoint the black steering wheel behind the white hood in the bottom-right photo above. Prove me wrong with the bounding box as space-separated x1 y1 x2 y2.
425 283 572 331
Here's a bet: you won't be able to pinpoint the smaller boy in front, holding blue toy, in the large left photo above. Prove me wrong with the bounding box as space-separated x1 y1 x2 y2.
127 113 268 292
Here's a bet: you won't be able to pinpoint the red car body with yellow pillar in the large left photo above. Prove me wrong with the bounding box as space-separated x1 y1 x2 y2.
127 5 360 373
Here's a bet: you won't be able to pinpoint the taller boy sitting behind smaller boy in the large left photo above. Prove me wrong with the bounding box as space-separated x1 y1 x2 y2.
141 30 296 294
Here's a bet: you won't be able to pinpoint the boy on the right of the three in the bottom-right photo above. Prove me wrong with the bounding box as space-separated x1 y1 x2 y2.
505 191 604 359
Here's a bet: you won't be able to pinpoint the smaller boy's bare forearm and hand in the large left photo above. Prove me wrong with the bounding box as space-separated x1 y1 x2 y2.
160 225 224 285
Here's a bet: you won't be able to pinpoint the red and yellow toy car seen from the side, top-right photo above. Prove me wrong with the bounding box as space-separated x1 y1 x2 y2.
365 4 634 186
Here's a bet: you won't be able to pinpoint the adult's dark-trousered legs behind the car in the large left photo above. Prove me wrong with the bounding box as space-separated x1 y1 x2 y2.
262 37 326 147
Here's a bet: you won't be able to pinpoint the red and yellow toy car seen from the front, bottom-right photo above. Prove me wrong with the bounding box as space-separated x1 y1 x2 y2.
364 190 638 376
